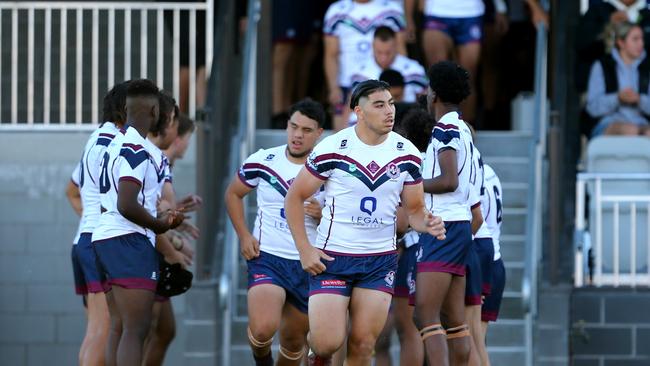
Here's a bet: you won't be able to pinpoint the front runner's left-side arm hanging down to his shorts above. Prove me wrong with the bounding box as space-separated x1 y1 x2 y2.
284 168 334 275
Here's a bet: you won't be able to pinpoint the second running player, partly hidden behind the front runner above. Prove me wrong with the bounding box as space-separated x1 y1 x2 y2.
225 99 325 366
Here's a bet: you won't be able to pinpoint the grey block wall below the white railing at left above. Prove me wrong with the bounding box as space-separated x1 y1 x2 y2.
0 129 195 366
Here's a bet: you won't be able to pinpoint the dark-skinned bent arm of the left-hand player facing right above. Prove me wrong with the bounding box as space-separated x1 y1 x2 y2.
117 179 183 234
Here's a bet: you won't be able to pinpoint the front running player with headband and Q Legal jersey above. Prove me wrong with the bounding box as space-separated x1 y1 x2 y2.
285 80 444 366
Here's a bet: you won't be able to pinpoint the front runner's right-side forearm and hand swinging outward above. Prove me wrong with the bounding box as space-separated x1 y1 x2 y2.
401 183 445 240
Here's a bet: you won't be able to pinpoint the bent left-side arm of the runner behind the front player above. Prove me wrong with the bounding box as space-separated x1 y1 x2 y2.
224 176 260 260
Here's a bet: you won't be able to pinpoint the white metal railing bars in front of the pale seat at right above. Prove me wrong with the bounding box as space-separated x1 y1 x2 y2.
574 173 650 287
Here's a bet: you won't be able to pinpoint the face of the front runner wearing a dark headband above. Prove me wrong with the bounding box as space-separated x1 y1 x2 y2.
355 90 395 135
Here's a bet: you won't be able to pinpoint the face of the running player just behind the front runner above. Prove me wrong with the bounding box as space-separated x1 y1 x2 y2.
287 111 323 158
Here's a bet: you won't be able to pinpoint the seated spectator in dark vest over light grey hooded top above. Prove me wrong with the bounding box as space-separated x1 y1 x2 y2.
587 22 650 137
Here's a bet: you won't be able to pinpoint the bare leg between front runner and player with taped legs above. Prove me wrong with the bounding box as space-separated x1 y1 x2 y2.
393 297 424 366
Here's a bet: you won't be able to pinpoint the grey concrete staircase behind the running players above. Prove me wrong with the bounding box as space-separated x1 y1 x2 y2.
220 130 531 365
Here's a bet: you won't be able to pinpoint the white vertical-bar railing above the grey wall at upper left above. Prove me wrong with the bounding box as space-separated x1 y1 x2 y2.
0 0 214 128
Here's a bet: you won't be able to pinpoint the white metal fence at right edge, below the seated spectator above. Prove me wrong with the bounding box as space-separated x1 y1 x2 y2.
574 173 650 287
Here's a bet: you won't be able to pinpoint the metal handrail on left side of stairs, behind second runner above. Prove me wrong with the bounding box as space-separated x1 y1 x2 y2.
219 0 261 365
